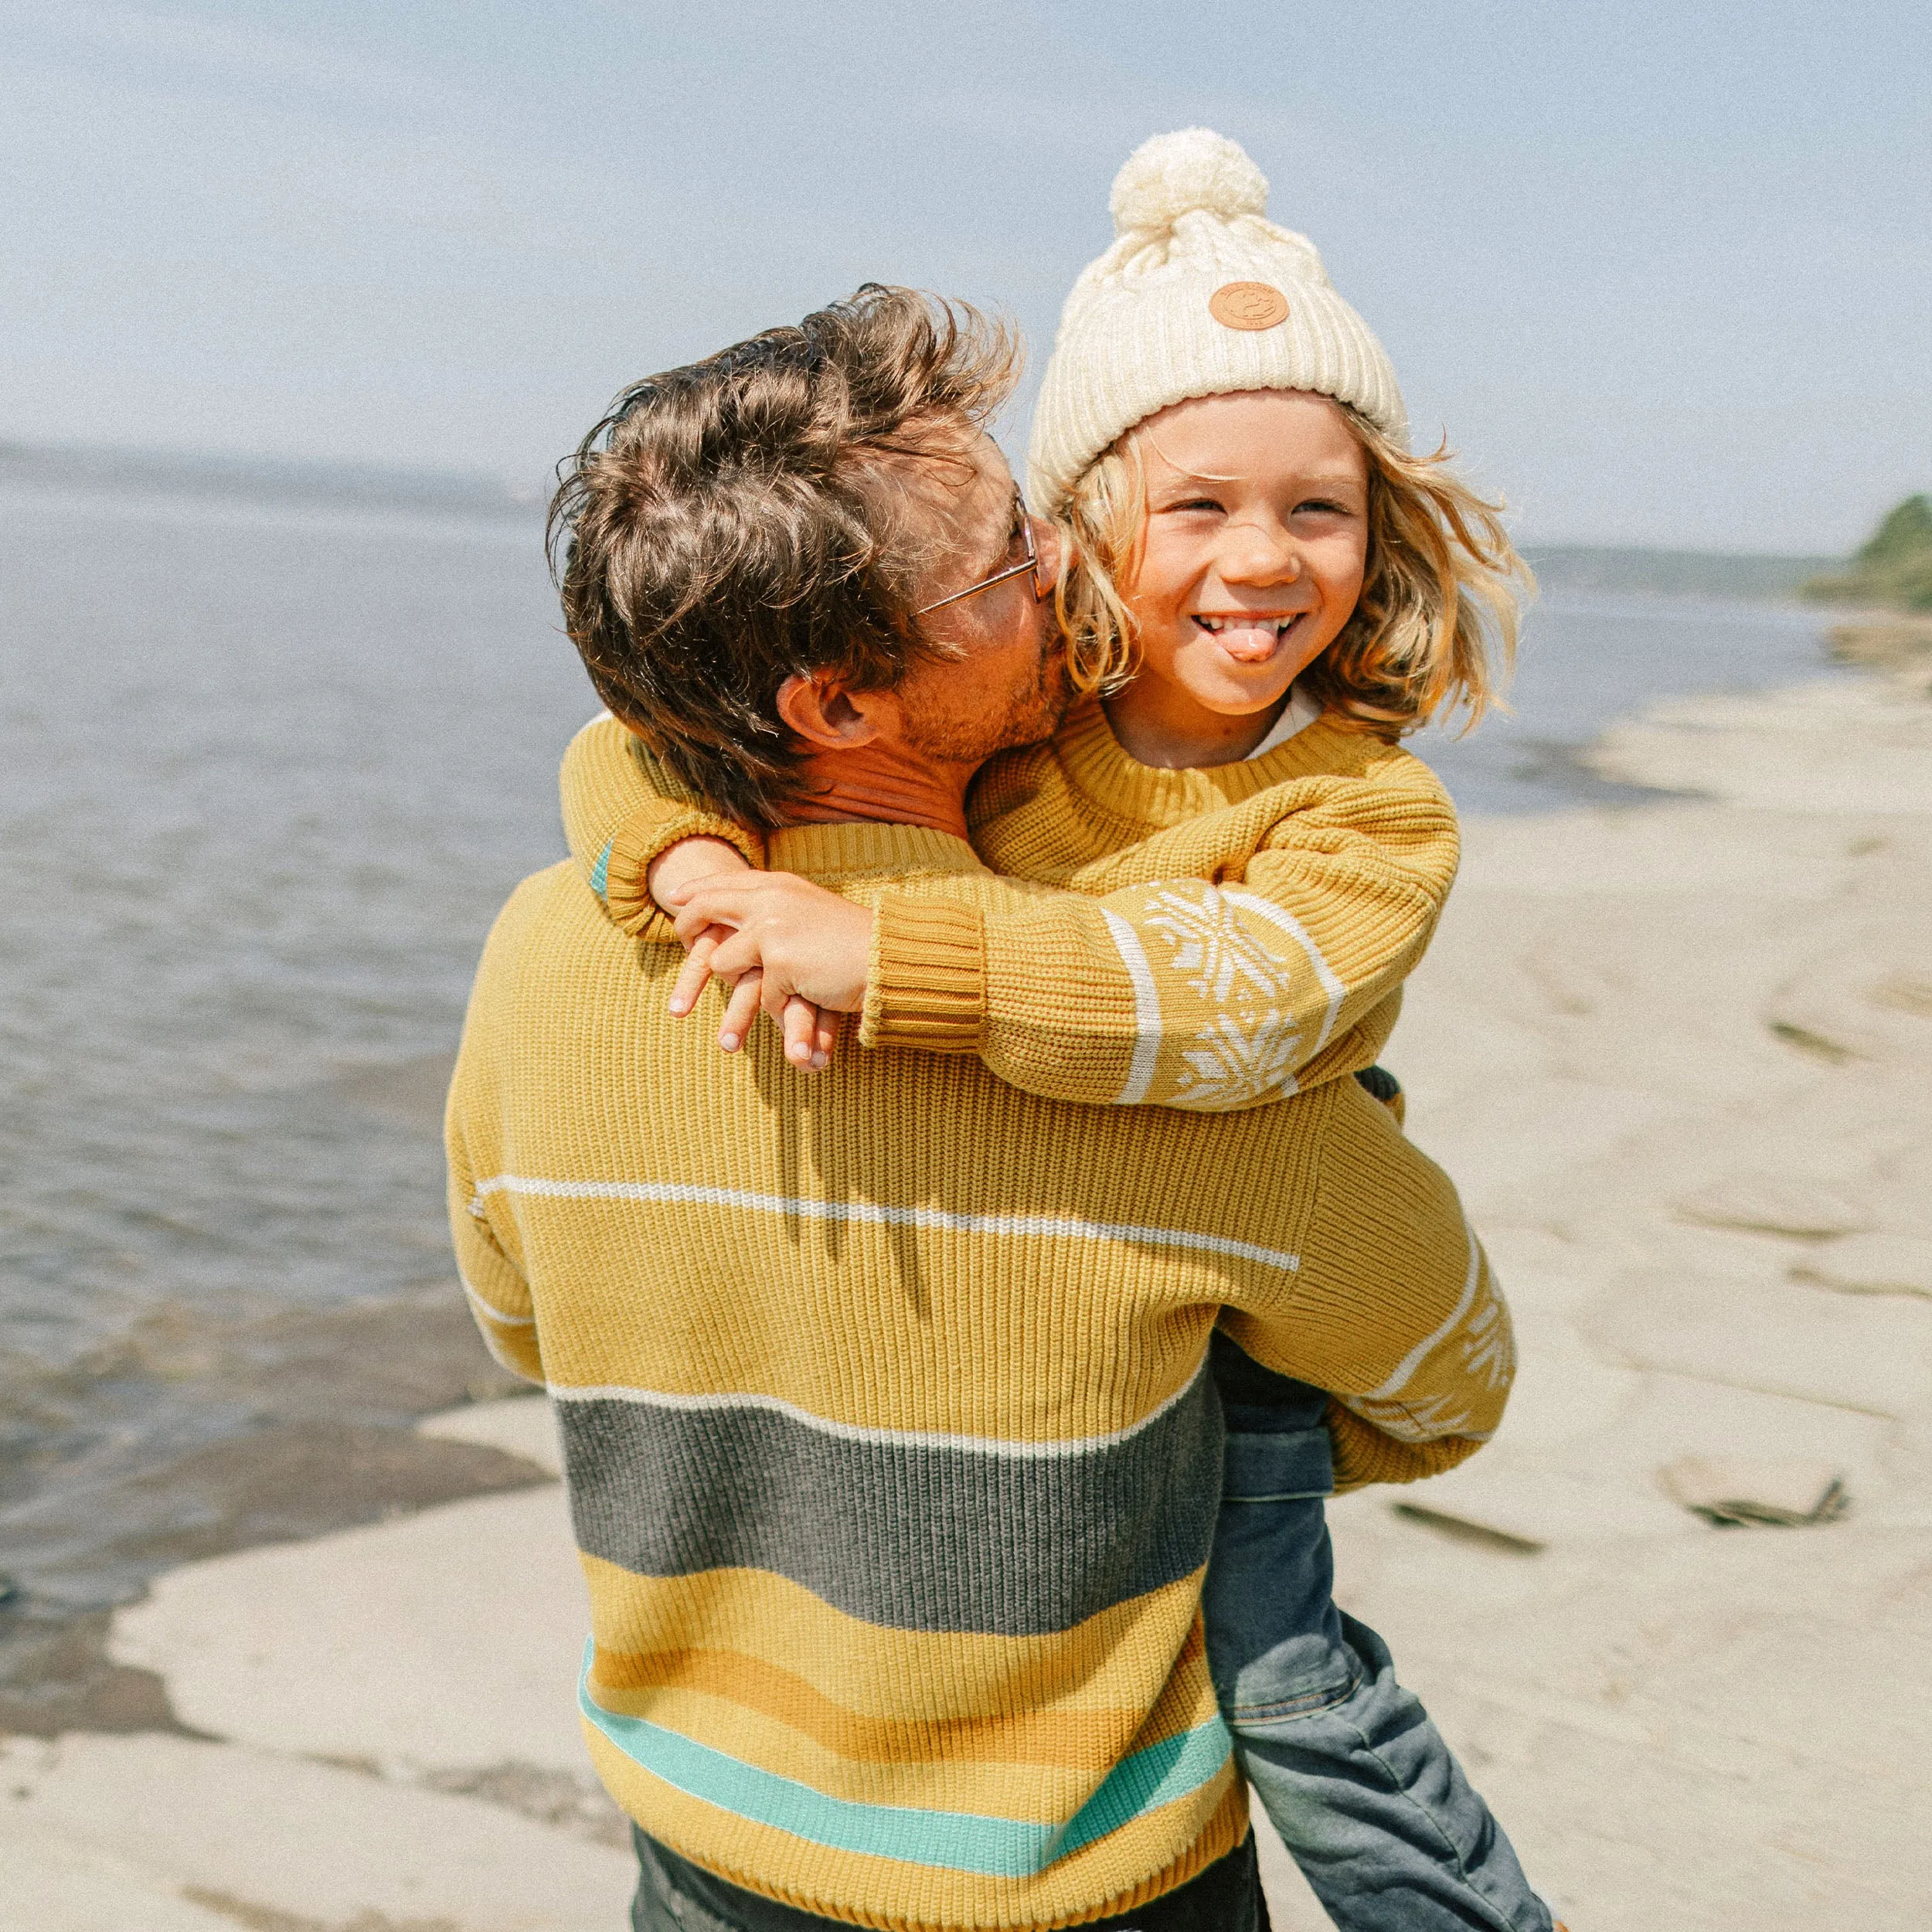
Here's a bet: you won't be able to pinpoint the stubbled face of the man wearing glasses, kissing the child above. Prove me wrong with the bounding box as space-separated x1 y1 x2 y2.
893 429 1073 765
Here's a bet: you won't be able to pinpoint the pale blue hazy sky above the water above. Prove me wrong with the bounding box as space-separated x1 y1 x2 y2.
0 0 1932 551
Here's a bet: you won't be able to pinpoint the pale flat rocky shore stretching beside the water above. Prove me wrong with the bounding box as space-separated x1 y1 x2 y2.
0 668 1932 1932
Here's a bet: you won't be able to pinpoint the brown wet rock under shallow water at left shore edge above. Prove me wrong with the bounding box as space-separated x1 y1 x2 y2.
0 1287 536 1737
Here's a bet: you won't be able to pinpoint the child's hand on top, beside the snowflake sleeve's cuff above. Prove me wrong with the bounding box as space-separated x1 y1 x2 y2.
671 869 873 1070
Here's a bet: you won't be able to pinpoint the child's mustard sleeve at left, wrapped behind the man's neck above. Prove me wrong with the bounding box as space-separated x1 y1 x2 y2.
563 711 765 943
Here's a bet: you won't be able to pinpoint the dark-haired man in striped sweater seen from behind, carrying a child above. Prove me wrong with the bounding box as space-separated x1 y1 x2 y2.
451 290 1503 1932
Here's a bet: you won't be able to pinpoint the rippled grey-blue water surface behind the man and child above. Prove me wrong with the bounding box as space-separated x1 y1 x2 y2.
0 464 1832 1662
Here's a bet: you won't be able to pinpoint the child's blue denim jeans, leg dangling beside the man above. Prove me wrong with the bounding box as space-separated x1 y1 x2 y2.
1202 1360 1552 1932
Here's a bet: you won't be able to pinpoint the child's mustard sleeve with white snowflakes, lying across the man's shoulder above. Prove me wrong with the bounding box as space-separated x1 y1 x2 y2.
860 760 1459 1113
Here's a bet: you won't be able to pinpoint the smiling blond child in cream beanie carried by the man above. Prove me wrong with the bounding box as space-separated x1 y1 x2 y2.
564 130 1552 1932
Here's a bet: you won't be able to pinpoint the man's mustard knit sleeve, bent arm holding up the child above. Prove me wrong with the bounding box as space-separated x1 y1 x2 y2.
1223 1080 1517 1490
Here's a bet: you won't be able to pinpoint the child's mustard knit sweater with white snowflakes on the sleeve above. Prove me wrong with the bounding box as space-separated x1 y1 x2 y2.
564 707 1459 1113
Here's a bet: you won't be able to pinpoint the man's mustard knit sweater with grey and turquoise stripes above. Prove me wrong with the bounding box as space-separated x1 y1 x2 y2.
448 742 1511 1932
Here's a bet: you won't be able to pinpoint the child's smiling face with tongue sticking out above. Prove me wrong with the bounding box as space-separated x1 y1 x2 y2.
1123 390 1368 726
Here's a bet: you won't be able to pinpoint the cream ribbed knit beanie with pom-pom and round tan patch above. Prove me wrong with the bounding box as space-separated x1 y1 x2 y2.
1028 128 1409 512
